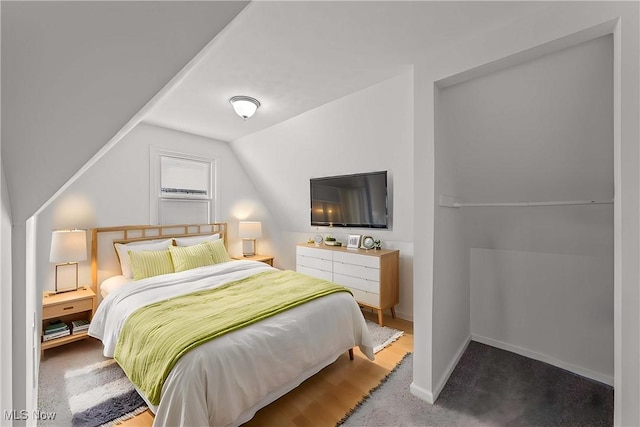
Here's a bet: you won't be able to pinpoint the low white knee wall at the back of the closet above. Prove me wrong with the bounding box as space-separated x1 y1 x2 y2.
470 244 613 385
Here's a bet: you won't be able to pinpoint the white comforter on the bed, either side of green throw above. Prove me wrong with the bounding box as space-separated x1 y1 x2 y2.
89 260 373 426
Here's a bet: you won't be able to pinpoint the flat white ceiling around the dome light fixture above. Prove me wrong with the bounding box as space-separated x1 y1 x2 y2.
145 1 546 141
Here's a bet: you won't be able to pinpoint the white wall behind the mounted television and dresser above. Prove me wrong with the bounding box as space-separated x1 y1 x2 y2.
232 72 414 319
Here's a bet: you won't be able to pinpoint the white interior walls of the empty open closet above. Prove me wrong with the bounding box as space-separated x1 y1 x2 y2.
433 36 614 385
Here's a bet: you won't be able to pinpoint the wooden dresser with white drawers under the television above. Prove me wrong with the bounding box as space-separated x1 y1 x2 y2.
296 244 400 325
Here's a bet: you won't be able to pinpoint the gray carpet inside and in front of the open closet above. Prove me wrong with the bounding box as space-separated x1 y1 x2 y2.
338 341 613 427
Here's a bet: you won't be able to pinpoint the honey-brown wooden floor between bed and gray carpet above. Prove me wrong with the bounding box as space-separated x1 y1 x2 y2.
121 312 413 427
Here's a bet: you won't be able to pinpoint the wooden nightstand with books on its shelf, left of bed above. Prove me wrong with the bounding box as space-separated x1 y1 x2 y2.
40 288 97 357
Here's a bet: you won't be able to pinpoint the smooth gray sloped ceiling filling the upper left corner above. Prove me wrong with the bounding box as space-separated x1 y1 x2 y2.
1 1 247 221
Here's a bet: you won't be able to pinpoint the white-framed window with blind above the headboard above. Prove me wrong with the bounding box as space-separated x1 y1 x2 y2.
150 148 215 224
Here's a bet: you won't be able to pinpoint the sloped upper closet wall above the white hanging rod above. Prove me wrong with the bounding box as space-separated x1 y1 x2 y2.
436 35 613 202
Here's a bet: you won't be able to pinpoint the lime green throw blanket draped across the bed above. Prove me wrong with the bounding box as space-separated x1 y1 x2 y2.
114 271 350 405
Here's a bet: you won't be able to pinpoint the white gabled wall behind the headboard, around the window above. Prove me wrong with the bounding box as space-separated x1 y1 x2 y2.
37 123 271 291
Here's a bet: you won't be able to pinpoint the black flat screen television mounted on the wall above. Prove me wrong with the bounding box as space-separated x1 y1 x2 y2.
310 171 389 228
